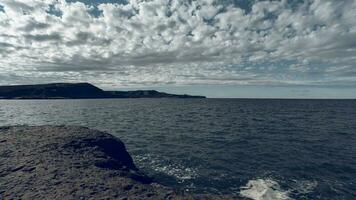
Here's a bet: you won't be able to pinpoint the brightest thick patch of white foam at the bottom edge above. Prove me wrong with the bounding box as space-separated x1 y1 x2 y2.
240 179 292 200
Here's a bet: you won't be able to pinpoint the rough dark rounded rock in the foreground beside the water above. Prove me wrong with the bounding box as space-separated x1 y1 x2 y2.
0 126 239 199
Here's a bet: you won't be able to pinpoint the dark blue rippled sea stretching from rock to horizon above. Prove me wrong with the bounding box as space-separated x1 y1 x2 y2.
0 99 356 200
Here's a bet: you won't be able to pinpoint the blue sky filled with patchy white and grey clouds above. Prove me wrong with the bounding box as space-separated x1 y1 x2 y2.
0 0 356 98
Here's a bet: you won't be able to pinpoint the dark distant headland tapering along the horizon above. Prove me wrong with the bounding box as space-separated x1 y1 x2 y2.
0 83 205 99
